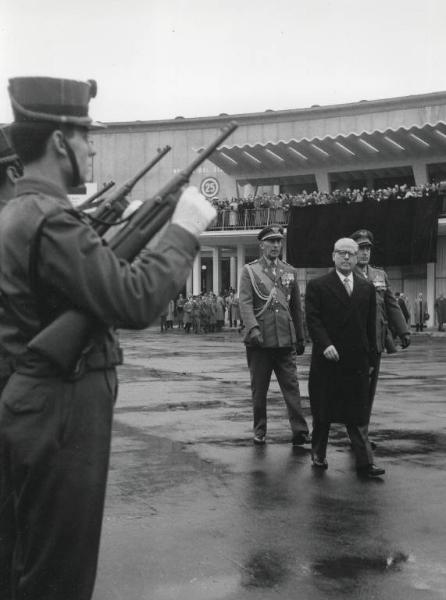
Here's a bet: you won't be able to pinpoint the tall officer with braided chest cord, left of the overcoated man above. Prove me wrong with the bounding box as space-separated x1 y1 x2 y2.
239 225 310 445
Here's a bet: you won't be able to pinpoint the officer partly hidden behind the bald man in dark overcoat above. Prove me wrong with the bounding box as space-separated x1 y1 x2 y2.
350 229 410 447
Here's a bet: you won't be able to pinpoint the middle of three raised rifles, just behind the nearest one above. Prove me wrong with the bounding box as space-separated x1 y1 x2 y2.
89 146 172 235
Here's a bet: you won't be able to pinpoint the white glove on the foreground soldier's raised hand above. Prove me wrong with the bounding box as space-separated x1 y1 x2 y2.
172 186 217 237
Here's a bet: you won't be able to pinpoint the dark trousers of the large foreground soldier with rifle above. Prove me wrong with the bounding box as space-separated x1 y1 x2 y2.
0 369 117 600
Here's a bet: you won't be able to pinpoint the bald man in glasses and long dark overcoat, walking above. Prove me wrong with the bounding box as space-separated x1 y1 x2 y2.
305 238 384 477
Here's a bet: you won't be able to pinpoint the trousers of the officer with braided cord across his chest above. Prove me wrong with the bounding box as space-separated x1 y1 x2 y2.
246 346 308 436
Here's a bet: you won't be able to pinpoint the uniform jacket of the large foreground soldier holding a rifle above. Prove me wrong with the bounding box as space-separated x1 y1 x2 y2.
0 177 198 370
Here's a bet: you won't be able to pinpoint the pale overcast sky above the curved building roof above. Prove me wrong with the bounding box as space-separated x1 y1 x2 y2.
0 0 446 123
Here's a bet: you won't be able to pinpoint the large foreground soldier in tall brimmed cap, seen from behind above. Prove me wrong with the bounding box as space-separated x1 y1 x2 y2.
0 77 216 600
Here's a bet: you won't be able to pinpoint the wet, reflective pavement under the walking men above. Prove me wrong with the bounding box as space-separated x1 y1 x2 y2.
94 329 446 600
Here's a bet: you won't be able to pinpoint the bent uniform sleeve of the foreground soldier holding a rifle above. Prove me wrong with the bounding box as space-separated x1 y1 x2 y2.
38 211 199 329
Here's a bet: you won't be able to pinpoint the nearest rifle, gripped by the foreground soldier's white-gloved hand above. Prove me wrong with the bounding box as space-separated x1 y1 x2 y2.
28 121 238 374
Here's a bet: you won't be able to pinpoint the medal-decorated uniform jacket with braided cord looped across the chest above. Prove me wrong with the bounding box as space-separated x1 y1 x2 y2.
239 257 304 348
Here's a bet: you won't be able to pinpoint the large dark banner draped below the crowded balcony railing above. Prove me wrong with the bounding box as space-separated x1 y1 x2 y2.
287 194 441 267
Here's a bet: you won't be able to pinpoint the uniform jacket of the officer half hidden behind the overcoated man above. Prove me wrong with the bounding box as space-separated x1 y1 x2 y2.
355 265 409 353
